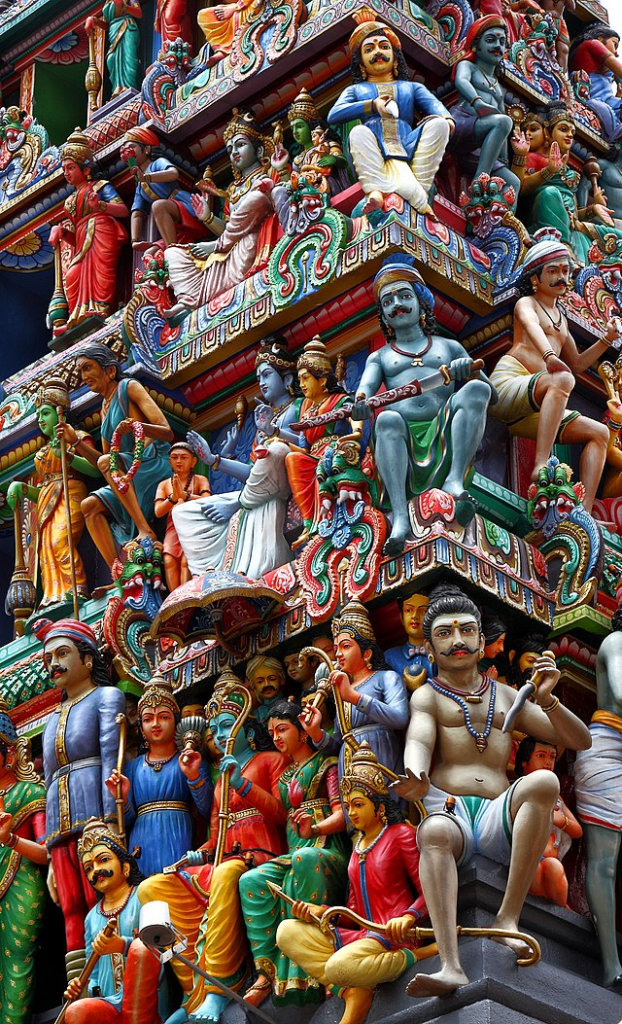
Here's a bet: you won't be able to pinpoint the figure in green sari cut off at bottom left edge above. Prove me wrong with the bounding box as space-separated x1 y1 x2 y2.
0 699 47 1024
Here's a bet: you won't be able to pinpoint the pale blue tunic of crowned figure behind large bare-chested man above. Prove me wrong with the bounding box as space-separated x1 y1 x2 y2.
318 671 409 799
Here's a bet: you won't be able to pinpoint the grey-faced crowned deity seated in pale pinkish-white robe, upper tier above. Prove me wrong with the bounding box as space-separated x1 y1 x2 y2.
166 109 288 317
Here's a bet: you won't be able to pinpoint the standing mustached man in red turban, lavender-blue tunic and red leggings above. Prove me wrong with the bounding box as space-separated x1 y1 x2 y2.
35 618 125 980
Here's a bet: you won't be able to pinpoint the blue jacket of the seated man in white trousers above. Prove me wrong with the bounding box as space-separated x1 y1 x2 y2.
327 81 450 163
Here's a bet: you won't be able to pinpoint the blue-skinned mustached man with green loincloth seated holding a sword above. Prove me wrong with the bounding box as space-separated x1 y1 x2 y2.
353 256 496 554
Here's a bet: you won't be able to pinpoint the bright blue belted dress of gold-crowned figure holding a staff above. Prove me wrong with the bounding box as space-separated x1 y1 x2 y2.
124 756 214 876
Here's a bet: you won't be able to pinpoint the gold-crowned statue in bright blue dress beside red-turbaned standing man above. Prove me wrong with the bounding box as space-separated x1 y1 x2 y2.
106 686 213 876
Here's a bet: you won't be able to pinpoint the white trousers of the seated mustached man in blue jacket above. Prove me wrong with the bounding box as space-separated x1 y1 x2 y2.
349 117 450 211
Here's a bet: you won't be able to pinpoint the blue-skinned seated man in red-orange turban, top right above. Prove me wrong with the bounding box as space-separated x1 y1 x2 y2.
450 14 529 208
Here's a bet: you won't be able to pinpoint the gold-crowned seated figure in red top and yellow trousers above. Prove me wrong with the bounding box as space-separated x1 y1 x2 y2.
277 743 427 1024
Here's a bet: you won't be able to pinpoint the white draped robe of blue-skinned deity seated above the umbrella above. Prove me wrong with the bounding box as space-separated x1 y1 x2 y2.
172 441 293 579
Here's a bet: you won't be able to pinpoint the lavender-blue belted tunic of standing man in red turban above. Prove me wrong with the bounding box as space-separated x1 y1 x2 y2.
43 686 125 847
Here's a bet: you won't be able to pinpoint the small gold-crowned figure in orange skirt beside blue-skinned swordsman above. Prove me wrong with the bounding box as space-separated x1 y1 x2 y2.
285 335 359 547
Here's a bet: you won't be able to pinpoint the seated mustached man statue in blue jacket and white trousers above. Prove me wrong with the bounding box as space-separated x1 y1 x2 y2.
328 7 454 213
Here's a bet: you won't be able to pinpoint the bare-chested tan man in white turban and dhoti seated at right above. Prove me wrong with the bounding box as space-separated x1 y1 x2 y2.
491 228 622 512
